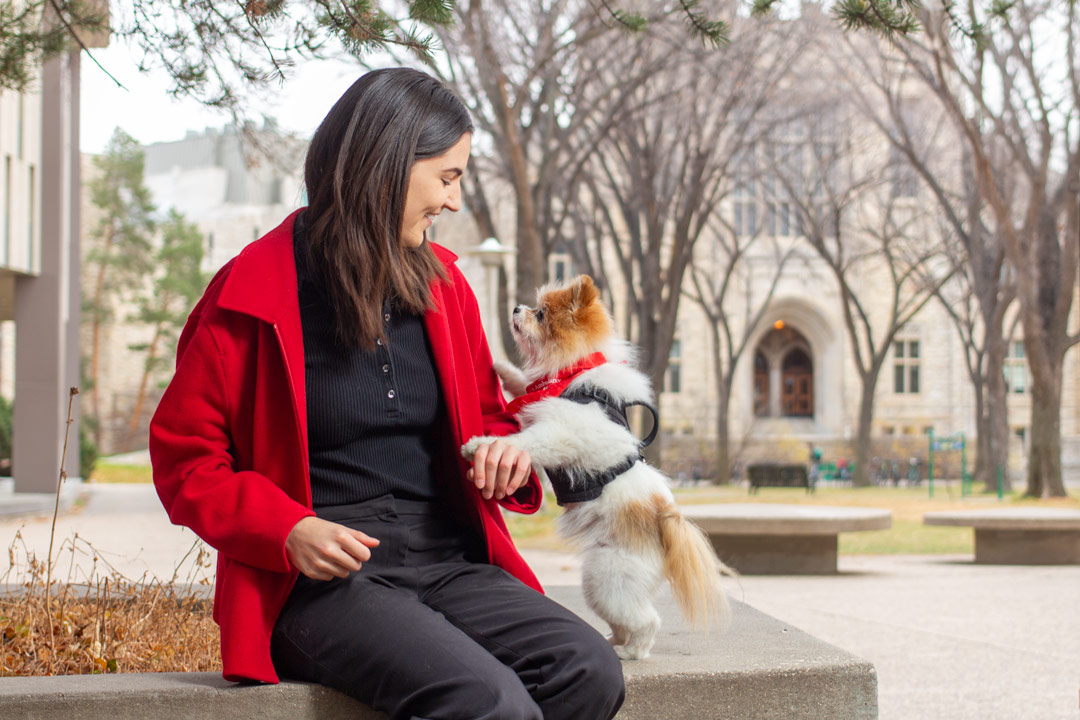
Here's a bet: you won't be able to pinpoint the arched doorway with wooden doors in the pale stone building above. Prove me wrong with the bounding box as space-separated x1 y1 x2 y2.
754 322 814 418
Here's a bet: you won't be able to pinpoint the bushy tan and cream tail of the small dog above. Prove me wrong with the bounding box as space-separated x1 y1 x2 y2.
658 502 734 628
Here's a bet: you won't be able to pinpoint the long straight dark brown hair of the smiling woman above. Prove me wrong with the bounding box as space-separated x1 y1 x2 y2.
303 68 473 348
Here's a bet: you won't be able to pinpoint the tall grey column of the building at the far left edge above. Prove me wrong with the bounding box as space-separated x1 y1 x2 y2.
12 51 81 492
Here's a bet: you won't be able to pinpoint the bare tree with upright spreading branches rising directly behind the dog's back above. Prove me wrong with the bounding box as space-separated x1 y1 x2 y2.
572 16 806 468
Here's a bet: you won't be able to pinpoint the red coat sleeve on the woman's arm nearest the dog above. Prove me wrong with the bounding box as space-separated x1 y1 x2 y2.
454 267 543 515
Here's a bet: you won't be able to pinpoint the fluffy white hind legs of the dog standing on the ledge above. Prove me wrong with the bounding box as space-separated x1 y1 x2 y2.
581 546 661 660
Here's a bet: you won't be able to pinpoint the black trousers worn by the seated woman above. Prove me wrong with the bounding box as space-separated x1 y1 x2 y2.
270 495 624 720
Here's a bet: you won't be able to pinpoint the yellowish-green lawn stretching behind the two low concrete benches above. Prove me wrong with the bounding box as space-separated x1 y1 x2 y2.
507 484 1080 555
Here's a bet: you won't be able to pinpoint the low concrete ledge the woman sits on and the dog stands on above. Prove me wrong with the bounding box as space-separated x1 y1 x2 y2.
0 586 877 720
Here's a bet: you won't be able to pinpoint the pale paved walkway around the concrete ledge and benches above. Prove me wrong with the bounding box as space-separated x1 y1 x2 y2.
0 485 1080 720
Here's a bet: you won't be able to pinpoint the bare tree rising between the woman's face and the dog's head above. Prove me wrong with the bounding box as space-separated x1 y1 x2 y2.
419 0 659 360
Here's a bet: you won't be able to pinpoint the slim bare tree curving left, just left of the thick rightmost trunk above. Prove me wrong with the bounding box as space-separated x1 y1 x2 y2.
833 47 1016 491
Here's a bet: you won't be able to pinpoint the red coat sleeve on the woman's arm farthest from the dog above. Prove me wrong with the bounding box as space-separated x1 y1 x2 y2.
150 307 313 573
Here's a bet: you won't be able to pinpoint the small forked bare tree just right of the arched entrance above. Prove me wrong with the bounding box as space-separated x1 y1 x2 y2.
770 99 951 486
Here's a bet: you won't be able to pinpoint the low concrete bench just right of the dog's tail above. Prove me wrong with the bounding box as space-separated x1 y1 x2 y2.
683 503 892 575
